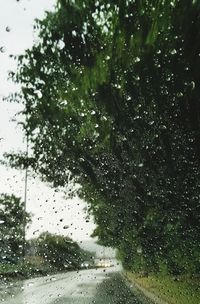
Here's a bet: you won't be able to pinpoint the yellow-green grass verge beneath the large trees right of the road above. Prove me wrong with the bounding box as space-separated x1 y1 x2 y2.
125 272 200 304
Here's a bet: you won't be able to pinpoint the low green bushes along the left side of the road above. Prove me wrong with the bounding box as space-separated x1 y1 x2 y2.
0 232 95 280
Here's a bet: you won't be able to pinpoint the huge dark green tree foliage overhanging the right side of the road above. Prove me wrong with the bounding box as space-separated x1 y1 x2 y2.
7 0 200 274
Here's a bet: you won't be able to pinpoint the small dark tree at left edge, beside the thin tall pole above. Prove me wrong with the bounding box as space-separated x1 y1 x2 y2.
0 194 30 263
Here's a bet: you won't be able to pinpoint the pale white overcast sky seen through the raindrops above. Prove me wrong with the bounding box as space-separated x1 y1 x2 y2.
0 0 114 256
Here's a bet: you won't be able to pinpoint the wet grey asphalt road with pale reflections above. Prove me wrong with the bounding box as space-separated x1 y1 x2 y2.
0 268 147 304
